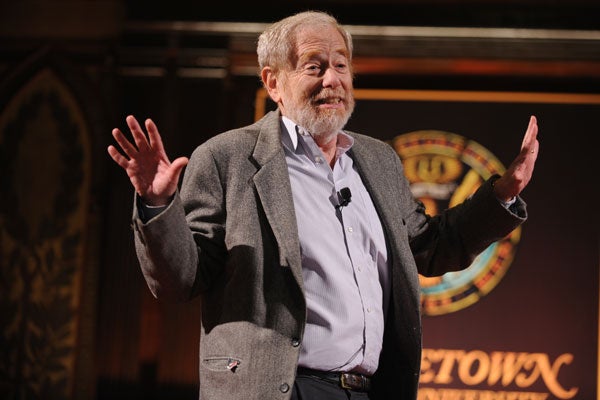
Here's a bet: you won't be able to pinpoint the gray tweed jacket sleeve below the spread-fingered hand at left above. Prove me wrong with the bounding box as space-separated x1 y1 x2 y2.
133 142 224 301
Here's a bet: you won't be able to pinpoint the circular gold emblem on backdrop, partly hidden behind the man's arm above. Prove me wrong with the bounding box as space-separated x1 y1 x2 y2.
392 131 521 315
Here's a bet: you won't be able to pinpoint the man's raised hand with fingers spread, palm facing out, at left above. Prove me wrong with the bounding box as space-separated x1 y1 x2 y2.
108 115 188 206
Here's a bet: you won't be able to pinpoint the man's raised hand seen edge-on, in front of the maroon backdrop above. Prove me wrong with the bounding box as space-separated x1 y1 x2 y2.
494 116 540 201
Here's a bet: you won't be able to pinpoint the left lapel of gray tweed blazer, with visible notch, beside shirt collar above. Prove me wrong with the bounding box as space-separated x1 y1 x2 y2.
252 111 302 287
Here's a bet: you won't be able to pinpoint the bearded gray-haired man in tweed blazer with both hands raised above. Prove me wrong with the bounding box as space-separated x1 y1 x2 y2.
108 12 538 400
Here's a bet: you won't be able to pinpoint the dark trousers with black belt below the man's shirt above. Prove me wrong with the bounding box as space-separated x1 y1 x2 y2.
292 375 369 400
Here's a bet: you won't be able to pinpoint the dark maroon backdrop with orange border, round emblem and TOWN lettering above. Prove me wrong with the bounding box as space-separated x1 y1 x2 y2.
256 89 600 400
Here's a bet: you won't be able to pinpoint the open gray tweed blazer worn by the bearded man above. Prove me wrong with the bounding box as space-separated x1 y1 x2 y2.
133 112 526 400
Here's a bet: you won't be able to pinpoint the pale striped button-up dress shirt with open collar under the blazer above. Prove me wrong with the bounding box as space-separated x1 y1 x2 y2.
282 117 390 375
